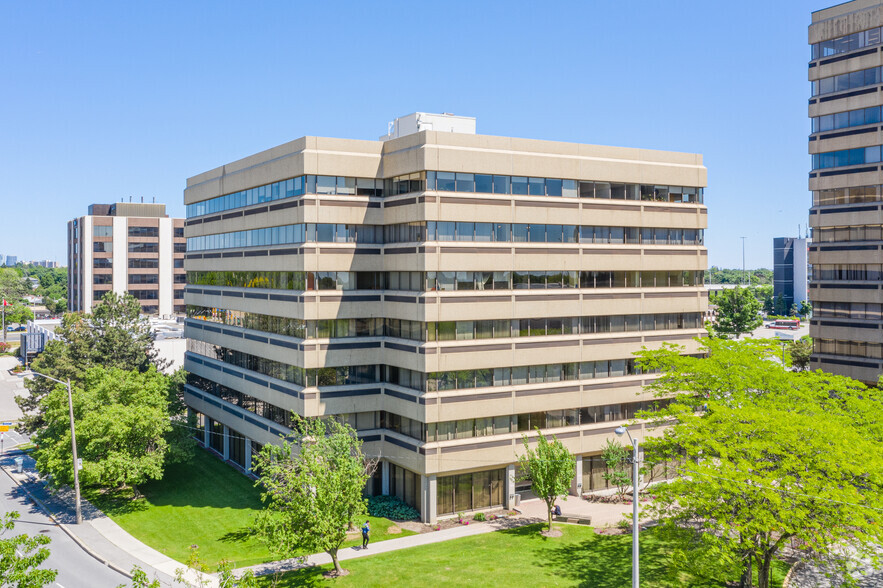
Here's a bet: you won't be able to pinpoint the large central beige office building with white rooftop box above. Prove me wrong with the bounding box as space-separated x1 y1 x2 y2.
184 113 707 521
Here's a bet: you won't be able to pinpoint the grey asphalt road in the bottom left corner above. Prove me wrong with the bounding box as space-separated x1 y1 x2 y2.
0 460 129 588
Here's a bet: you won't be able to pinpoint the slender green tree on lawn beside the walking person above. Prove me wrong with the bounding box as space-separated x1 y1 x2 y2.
255 414 369 575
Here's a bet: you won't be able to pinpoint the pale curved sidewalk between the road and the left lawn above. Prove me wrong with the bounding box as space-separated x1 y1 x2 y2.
0 451 211 586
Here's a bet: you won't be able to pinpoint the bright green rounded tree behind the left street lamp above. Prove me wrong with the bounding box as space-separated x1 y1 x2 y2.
34 367 192 490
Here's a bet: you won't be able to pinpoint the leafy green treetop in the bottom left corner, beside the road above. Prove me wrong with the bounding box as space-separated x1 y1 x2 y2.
0 511 58 588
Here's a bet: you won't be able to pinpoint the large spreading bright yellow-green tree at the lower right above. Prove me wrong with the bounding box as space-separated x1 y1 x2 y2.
640 340 883 588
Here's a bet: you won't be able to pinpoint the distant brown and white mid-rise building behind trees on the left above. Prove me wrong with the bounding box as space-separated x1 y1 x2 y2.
67 202 186 316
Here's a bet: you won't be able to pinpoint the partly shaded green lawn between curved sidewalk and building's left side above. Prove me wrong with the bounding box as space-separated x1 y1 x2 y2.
86 450 413 567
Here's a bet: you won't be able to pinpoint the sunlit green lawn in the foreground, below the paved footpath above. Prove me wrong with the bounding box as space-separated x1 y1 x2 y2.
261 525 787 588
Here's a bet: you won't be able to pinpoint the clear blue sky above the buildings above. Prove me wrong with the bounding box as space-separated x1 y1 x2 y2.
0 0 833 267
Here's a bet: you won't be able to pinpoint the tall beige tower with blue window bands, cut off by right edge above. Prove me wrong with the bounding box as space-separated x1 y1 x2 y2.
809 0 883 382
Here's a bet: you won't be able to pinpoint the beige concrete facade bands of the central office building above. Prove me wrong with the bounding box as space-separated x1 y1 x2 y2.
184 126 707 521
